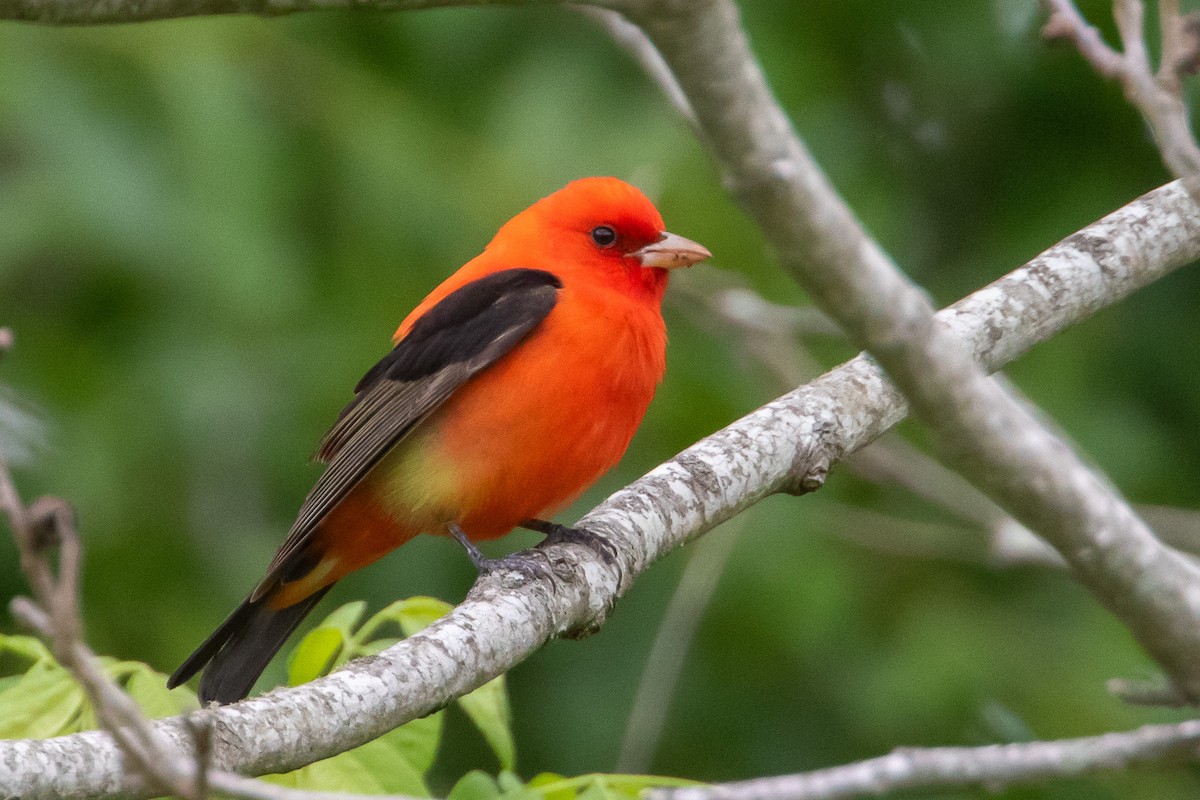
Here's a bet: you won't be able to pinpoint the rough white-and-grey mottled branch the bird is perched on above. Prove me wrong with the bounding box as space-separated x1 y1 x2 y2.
0 176 1200 800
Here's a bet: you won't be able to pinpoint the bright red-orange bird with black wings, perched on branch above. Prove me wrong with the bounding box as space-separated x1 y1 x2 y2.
168 178 710 703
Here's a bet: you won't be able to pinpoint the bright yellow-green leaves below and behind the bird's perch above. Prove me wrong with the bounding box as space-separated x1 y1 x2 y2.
0 606 690 800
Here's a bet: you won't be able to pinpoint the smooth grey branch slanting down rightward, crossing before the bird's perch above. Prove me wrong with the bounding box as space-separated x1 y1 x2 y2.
623 0 1200 698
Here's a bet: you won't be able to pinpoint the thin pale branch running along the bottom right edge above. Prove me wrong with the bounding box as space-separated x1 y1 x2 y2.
650 720 1200 800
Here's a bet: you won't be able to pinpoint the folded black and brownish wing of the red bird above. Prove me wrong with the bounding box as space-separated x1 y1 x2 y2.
250 269 563 601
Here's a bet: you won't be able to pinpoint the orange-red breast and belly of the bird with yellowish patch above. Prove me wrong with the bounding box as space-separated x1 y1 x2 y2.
380 284 666 539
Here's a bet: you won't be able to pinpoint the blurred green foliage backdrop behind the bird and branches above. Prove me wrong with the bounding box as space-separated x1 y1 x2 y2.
0 0 1200 799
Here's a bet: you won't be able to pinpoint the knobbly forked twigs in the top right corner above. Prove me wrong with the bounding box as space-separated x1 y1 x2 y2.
1042 0 1200 187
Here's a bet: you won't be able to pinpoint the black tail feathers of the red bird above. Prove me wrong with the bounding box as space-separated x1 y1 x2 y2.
167 584 332 705
